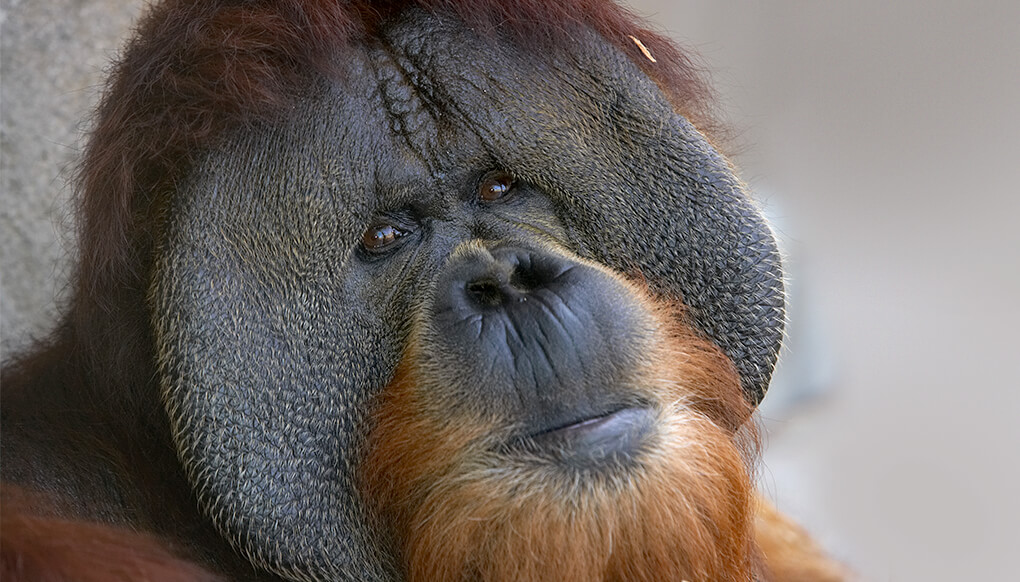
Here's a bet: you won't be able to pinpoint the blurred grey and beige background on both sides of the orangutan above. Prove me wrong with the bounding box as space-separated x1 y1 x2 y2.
0 0 1020 581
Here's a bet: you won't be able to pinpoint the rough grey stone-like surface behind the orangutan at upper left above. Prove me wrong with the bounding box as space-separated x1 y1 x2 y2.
0 0 144 359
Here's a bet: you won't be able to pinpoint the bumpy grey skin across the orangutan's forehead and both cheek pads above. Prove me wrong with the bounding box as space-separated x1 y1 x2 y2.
151 6 783 580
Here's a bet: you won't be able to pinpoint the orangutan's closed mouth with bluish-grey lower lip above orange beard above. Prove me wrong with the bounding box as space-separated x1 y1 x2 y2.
519 408 656 468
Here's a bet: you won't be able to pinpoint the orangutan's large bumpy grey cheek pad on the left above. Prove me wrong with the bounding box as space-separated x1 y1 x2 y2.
151 124 400 579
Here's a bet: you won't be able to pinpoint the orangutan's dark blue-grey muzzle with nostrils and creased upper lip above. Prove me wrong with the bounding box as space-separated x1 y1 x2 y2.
423 245 648 428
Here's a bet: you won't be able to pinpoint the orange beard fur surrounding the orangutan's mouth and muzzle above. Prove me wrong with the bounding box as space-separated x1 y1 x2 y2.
364 279 767 582
